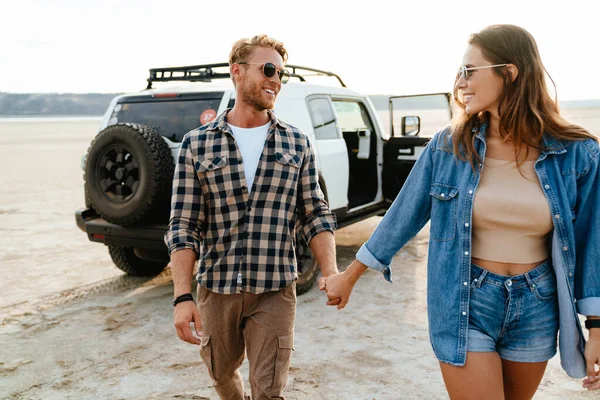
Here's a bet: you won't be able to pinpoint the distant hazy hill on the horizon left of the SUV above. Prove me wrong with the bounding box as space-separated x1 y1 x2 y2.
0 92 122 116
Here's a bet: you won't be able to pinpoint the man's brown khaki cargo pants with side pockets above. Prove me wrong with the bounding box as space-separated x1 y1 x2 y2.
197 282 296 400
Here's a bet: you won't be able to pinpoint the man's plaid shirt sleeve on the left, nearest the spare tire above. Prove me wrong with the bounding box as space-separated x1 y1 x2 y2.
164 135 205 258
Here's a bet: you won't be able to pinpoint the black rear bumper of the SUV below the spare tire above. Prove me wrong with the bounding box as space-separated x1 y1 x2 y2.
75 208 167 250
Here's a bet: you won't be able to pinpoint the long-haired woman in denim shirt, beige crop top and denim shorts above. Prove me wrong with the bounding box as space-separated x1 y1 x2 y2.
321 25 600 399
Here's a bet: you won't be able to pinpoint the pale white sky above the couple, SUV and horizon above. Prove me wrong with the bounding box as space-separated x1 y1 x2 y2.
0 0 600 101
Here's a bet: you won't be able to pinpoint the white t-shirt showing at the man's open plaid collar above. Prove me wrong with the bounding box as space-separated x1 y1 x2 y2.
227 121 271 193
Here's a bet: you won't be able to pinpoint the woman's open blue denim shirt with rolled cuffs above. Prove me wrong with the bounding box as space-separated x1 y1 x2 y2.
356 124 600 378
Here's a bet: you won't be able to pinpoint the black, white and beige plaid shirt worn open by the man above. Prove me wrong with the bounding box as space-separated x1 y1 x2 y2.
165 110 336 294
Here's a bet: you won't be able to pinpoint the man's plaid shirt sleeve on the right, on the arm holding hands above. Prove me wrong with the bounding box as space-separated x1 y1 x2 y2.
298 138 337 243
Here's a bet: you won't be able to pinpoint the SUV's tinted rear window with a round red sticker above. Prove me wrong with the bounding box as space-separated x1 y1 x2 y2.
108 98 221 142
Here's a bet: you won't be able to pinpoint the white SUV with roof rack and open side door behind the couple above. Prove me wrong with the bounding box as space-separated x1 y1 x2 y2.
75 63 451 293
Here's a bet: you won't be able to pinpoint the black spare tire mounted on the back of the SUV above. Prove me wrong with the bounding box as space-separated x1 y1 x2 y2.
84 123 174 226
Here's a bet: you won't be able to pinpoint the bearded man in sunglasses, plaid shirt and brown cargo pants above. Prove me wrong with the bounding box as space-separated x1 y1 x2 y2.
165 35 338 400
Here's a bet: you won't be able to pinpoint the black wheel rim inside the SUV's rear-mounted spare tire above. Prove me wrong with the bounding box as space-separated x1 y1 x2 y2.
96 145 140 203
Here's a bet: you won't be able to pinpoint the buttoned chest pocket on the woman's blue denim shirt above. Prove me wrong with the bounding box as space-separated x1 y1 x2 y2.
429 183 458 242
